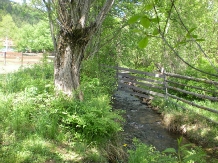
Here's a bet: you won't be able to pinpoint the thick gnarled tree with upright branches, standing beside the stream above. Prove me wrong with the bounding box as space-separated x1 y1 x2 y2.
43 0 114 100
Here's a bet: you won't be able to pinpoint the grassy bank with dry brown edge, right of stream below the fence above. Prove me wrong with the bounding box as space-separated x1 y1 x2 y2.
152 98 218 162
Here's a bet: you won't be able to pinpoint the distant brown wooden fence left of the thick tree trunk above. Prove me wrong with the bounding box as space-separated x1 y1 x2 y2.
0 52 42 66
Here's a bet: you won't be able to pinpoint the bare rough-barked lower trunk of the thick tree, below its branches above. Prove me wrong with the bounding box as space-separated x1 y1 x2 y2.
54 29 87 100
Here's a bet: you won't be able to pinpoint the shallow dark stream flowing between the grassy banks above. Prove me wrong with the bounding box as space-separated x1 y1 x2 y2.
111 91 183 151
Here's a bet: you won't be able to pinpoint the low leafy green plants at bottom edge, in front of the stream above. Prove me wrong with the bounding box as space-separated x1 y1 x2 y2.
128 138 206 163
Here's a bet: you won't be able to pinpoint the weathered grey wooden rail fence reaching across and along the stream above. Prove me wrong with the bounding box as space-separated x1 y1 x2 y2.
105 66 218 124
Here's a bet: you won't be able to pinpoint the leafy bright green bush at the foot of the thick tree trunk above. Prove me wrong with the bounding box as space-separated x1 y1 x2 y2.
51 96 121 141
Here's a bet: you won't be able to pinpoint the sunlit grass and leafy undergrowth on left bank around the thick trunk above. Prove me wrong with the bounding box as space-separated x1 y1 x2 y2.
0 62 122 163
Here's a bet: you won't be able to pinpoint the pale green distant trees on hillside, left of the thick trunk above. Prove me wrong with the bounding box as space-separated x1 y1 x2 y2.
0 2 53 52
